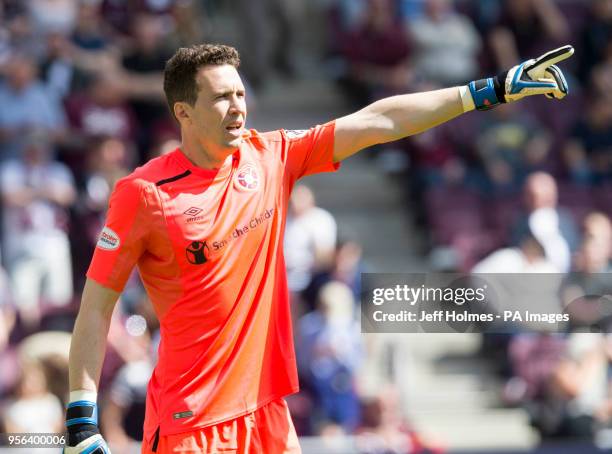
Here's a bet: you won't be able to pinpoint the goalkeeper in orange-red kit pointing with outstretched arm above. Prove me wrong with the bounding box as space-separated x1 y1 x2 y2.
65 45 573 454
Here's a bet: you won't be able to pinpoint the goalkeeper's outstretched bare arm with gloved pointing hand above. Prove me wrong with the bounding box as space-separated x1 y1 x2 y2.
334 46 574 162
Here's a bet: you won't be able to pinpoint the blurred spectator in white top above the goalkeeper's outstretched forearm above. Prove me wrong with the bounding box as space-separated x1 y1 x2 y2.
408 0 482 86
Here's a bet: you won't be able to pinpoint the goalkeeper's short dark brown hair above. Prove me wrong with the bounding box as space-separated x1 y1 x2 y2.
164 44 240 121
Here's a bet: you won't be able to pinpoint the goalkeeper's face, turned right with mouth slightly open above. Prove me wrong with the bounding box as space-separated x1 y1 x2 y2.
189 65 247 155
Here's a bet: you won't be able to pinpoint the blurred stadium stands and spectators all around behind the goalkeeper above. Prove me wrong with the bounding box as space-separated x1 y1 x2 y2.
0 0 612 454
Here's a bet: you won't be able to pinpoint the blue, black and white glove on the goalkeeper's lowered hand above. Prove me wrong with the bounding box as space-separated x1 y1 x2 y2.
64 392 110 454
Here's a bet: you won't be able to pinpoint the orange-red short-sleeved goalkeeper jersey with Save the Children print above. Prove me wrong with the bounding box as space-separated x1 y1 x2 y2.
87 122 338 440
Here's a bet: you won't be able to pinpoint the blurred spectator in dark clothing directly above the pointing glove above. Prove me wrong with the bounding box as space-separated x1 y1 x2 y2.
490 0 569 68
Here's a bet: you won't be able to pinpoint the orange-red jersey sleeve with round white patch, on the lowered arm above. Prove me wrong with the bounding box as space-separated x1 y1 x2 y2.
87 179 151 292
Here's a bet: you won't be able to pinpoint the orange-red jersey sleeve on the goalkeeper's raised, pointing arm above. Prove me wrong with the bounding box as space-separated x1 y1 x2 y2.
281 121 340 180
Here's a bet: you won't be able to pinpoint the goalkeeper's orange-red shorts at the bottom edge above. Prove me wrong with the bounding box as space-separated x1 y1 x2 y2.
142 399 302 454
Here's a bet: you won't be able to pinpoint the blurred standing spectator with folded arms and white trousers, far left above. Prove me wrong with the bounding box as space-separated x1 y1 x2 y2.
0 134 76 327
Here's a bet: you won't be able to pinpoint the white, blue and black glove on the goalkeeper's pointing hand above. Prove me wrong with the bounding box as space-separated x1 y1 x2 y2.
461 46 574 112
